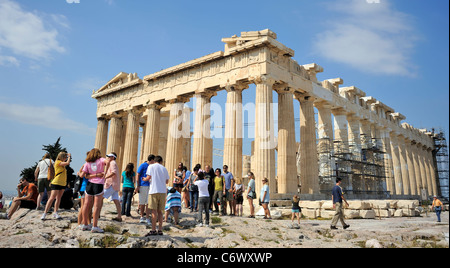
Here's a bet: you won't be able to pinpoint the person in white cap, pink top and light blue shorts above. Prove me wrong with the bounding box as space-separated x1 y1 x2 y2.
103 153 122 222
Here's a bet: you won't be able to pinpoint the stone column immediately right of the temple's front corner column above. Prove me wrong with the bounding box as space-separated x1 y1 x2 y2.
275 85 298 194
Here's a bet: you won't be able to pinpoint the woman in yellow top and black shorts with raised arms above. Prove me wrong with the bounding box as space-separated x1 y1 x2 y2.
41 152 71 220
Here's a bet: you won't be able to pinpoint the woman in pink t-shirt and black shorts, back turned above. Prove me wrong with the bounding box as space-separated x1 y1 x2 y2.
81 148 109 233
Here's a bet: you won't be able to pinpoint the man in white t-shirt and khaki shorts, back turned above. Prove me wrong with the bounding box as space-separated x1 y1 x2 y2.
144 156 170 235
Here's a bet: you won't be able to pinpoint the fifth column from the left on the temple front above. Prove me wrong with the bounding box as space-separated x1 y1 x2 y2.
164 99 187 186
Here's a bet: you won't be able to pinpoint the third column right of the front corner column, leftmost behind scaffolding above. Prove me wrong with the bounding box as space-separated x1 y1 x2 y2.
314 101 335 186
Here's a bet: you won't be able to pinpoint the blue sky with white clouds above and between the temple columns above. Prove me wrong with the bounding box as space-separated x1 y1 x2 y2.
0 0 449 191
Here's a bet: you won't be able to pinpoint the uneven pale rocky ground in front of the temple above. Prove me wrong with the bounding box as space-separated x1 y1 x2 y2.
0 202 449 248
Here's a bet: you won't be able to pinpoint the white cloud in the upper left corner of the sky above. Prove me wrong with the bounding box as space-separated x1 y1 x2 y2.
0 0 68 64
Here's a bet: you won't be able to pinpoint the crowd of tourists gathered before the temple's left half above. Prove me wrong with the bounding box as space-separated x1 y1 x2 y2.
0 148 271 235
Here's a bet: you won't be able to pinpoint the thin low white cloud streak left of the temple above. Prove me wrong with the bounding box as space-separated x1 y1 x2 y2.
0 103 96 136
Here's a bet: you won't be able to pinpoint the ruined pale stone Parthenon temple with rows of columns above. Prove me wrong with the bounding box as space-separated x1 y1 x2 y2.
92 29 438 199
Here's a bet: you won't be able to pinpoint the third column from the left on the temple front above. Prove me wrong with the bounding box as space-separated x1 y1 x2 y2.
122 109 141 170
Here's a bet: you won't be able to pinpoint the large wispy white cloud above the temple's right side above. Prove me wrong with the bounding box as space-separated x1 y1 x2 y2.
314 0 418 76
